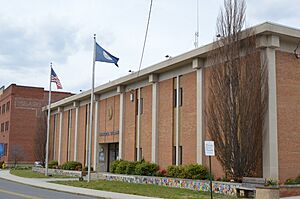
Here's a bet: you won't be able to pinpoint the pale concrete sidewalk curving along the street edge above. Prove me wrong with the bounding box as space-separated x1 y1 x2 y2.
0 170 159 199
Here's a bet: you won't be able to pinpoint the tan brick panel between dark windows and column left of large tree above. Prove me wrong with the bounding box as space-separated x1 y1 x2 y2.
180 72 197 164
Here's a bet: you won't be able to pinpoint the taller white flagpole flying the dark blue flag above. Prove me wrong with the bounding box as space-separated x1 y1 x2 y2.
87 34 96 182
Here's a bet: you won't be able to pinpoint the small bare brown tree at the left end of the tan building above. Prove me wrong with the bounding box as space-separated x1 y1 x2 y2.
34 111 47 163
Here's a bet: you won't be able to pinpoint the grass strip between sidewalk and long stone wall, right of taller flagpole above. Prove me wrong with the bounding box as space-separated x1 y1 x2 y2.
54 180 235 199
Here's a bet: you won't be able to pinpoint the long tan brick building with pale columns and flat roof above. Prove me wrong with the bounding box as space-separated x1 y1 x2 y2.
49 23 300 181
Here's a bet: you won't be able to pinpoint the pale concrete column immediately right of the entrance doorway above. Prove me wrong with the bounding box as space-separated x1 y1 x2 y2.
117 86 125 160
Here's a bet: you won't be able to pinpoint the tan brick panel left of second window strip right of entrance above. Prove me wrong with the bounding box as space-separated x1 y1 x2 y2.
158 79 173 168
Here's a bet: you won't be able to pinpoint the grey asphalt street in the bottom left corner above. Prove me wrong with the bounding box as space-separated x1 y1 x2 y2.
0 179 102 199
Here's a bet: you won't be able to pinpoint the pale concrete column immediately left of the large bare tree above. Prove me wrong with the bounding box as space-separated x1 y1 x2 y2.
193 58 204 164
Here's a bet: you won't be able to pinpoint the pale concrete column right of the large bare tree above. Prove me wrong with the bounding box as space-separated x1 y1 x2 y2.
258 35 280 179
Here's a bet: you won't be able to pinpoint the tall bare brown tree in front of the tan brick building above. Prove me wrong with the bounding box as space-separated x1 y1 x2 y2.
206 0 268 179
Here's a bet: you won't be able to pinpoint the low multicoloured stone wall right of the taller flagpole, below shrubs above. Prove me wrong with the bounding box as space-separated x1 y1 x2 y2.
97 173 241 195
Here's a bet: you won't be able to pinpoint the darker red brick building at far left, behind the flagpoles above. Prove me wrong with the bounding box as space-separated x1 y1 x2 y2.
0 84 71 165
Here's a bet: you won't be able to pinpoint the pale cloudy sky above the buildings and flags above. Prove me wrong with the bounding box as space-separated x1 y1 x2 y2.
0 0 300 93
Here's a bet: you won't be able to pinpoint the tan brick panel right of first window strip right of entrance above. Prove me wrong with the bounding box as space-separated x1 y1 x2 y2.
140 85 152 162
